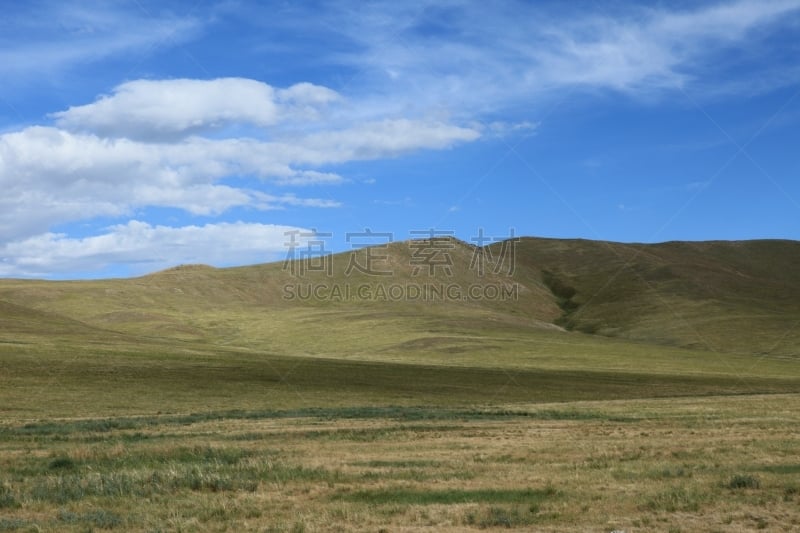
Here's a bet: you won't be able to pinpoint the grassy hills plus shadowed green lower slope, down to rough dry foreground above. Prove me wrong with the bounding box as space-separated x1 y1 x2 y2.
0 235 800 418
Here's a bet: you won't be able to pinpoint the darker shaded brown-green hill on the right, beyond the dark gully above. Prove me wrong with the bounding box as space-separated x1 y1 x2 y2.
506 239 800 355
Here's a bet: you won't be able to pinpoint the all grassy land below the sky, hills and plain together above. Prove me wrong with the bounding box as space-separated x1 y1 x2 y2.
0 239 800 531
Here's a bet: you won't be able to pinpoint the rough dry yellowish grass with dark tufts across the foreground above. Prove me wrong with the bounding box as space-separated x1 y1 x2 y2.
0 394 800 532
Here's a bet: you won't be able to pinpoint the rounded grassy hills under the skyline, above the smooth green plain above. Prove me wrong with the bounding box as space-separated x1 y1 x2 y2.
0 238 800 358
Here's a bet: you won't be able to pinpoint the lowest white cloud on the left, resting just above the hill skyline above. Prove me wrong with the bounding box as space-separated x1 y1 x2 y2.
0 220 308 277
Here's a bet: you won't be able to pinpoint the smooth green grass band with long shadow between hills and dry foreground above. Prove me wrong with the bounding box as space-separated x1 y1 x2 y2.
0 333 798 419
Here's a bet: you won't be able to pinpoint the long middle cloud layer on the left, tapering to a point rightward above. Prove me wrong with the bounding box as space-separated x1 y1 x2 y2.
0 113 480 242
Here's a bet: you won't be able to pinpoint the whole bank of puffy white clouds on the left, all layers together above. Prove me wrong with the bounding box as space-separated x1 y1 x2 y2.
0 78 481 275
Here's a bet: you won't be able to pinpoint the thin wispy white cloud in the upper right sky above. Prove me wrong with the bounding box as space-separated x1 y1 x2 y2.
530 0 800 92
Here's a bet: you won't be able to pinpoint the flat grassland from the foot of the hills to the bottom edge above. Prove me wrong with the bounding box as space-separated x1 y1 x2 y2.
0 326 800 531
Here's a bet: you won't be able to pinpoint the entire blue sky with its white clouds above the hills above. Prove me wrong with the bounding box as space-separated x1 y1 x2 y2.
0 0 800 279
